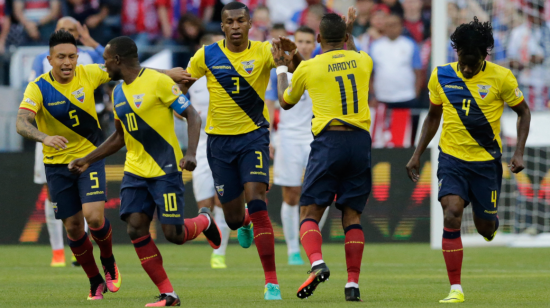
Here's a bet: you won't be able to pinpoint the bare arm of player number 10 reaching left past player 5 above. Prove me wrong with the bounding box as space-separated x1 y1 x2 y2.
68 120 125 174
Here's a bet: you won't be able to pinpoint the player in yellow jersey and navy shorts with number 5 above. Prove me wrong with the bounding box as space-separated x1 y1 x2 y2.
17 30 121 300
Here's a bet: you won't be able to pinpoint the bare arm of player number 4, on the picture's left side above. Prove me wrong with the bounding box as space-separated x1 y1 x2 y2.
406 104 443 182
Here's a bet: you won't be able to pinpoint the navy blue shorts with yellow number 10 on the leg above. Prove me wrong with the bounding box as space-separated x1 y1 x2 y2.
120 172 185 225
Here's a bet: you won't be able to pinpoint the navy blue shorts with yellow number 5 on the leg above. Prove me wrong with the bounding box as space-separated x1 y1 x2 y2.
44 160 107 219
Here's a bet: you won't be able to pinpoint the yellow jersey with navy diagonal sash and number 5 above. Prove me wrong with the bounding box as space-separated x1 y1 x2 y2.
19 64 110 164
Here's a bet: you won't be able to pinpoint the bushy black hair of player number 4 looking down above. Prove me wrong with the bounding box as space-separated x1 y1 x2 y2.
451 17 495 58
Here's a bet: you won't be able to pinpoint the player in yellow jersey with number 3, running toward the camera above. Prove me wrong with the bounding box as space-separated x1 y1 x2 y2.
184 2 302 300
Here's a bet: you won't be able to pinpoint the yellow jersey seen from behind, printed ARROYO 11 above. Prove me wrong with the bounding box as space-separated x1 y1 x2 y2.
283 49 373 136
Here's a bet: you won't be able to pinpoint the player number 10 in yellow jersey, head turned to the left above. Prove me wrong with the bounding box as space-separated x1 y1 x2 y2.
69 37 221 307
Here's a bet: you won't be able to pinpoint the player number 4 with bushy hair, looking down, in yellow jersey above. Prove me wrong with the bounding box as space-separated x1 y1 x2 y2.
407 17 531 303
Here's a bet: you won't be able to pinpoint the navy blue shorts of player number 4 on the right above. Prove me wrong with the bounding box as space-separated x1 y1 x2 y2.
437 152 502 221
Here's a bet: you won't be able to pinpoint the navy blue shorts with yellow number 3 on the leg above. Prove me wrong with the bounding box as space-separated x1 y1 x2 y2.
206 128 269 203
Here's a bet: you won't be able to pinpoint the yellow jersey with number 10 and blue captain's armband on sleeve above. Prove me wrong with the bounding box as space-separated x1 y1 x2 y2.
113 68 190 178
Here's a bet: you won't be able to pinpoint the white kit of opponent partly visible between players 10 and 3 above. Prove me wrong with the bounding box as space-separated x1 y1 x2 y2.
188 77 216 202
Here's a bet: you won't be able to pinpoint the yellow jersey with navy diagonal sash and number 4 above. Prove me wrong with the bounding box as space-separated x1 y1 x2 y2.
428 61 523 161
